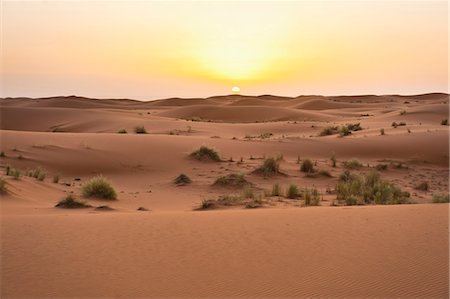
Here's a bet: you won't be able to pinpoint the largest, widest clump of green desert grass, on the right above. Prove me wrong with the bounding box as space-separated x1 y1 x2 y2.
336 171 410 205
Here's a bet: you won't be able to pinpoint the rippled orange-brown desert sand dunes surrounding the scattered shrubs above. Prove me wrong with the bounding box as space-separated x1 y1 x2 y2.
0 93 449 298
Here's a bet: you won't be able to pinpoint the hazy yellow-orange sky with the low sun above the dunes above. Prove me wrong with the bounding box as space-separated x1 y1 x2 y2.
1 0 448 99
